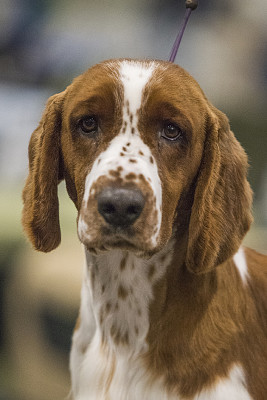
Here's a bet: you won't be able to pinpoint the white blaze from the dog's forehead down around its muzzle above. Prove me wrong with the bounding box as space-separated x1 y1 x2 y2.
79 61 162 245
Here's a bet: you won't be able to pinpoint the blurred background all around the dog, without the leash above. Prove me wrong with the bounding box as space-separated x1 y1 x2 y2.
0 0 267 400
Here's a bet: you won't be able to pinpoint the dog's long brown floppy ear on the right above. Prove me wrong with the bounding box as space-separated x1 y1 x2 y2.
186 106 252 273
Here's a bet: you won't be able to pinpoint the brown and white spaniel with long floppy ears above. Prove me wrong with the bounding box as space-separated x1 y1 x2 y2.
22 59 267 400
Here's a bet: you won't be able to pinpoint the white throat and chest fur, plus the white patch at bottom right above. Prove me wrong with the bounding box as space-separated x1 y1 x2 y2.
72 249 251 400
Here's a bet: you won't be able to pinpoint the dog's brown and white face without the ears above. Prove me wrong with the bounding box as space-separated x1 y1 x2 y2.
62 61 207 253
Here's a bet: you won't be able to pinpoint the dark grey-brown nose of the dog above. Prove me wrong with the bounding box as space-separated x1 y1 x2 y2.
97 187 145 227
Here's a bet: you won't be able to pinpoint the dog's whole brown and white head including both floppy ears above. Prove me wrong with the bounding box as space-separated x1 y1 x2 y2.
23 60 252 272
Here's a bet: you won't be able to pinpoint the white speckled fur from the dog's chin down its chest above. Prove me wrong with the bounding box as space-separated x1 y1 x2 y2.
71 244 175 400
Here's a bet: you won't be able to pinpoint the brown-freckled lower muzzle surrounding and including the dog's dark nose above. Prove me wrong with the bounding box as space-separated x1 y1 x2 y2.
78 173 159 252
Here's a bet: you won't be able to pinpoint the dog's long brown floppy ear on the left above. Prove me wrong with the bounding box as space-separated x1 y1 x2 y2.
22 92 64 252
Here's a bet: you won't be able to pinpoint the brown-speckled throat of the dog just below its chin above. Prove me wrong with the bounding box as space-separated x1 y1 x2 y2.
86 241 176 352
